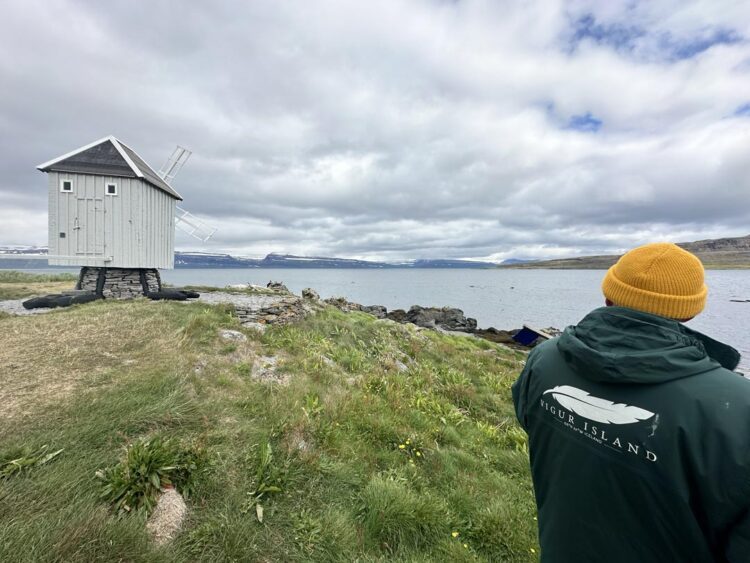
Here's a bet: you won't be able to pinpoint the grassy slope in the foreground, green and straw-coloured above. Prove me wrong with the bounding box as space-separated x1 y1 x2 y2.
0 276 539 562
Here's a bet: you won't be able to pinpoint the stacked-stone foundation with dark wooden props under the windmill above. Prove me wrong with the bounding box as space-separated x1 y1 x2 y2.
76 266 161 299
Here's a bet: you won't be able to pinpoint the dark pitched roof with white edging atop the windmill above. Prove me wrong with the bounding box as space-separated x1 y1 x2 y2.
37 135 182 200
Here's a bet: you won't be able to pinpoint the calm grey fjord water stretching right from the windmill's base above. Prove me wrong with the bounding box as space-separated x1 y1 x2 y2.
162 268 750 371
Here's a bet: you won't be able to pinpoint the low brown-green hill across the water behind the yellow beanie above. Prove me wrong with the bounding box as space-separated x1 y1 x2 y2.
500 235 750 270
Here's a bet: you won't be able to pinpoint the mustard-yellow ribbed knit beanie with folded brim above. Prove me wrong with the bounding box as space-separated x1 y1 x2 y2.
602 242 708 320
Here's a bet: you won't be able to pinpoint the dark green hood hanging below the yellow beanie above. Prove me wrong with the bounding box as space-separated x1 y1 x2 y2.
557 307 740 383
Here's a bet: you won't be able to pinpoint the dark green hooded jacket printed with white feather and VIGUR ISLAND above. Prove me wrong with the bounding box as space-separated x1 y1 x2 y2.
513 307 750 563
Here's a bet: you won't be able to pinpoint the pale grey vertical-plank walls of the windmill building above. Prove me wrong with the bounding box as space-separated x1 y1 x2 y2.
49 172 176 269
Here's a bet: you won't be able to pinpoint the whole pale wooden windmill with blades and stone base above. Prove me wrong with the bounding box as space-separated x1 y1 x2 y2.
37 136 216 297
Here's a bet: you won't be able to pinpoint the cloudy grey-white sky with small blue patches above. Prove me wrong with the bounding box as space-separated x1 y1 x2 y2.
0 0 750 260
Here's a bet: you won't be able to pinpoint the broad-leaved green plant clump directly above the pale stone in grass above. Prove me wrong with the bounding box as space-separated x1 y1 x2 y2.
96 437 208 513
